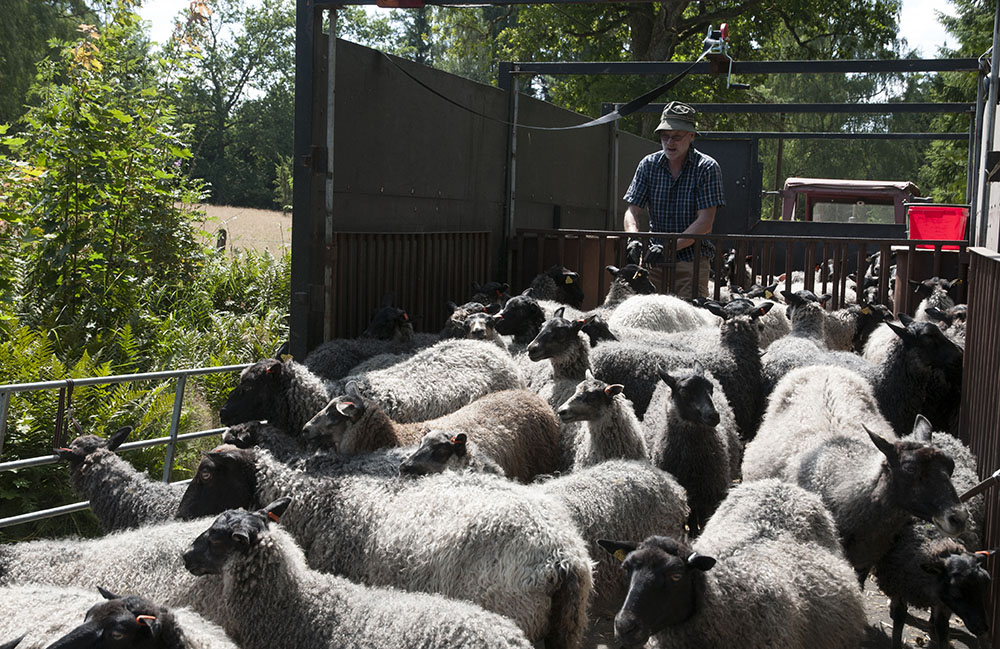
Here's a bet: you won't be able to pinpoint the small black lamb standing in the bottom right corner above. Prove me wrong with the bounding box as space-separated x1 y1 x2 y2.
875 522 992 649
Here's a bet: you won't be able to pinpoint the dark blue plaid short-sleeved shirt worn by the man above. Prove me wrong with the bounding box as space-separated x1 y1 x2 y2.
623 147 726 261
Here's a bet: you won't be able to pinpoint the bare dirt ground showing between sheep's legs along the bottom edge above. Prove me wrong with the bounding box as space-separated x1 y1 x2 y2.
583 579 980 649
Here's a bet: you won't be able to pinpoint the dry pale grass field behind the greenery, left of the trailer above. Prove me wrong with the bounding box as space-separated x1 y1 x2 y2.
193 204 292 257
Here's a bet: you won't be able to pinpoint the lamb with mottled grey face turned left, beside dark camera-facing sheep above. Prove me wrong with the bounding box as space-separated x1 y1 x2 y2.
557 370 647 470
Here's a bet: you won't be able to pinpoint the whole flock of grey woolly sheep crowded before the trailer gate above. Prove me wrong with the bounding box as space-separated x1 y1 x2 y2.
0 254 989 649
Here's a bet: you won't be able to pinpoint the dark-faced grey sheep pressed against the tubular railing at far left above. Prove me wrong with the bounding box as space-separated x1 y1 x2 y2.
55 426 184 532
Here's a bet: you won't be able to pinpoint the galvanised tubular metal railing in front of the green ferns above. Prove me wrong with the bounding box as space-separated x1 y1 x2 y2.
0 364 250 529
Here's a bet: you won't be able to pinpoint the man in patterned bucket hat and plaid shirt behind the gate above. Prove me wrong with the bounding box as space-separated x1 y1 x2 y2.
624 101 726 298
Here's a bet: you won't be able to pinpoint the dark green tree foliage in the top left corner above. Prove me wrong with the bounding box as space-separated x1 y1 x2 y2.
0 0 95 124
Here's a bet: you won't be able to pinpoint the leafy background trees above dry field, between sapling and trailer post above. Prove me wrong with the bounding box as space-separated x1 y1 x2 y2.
168 0 295 207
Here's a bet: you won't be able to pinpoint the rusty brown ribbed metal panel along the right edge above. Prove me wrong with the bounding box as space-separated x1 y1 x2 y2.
959 248 1000 645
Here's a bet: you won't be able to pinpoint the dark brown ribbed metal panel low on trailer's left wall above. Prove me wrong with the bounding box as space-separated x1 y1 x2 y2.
328 232 493 338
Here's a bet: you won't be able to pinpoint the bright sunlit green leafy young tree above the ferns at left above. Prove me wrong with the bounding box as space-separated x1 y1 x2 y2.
0 0 207 353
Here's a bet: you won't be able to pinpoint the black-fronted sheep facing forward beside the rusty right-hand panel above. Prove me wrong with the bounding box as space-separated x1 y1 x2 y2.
871 313 963 436
